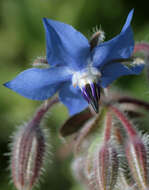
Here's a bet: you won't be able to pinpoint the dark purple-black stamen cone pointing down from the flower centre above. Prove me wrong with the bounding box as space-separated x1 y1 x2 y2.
83 83 100 113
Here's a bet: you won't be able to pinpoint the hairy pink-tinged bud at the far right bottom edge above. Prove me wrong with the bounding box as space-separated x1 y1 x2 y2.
126 137 149 190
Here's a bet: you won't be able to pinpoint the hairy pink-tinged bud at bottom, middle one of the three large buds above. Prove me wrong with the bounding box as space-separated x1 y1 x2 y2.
94 144 119 190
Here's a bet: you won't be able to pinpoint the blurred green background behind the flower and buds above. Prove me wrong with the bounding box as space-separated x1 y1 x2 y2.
0 0 149 190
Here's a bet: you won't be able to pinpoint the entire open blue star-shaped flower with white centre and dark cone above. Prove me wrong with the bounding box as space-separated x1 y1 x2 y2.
4 10 144 115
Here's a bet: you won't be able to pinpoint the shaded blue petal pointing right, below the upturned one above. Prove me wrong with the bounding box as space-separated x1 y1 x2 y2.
100 63 144 88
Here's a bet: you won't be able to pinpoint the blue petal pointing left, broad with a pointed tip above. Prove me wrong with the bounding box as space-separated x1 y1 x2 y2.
4 67 71 100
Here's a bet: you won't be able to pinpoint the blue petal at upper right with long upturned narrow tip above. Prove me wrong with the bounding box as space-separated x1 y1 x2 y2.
93 10 134 68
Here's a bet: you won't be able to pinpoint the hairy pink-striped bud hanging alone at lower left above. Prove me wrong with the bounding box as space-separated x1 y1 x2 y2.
11 122 46 190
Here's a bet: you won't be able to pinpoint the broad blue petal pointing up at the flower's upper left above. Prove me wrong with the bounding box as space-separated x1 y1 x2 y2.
43 18 90 70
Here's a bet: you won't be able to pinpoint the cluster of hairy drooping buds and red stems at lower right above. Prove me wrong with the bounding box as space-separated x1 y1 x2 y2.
66 100 149 190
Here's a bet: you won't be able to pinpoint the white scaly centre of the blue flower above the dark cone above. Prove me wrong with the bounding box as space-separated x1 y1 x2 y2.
72 66 101 88
